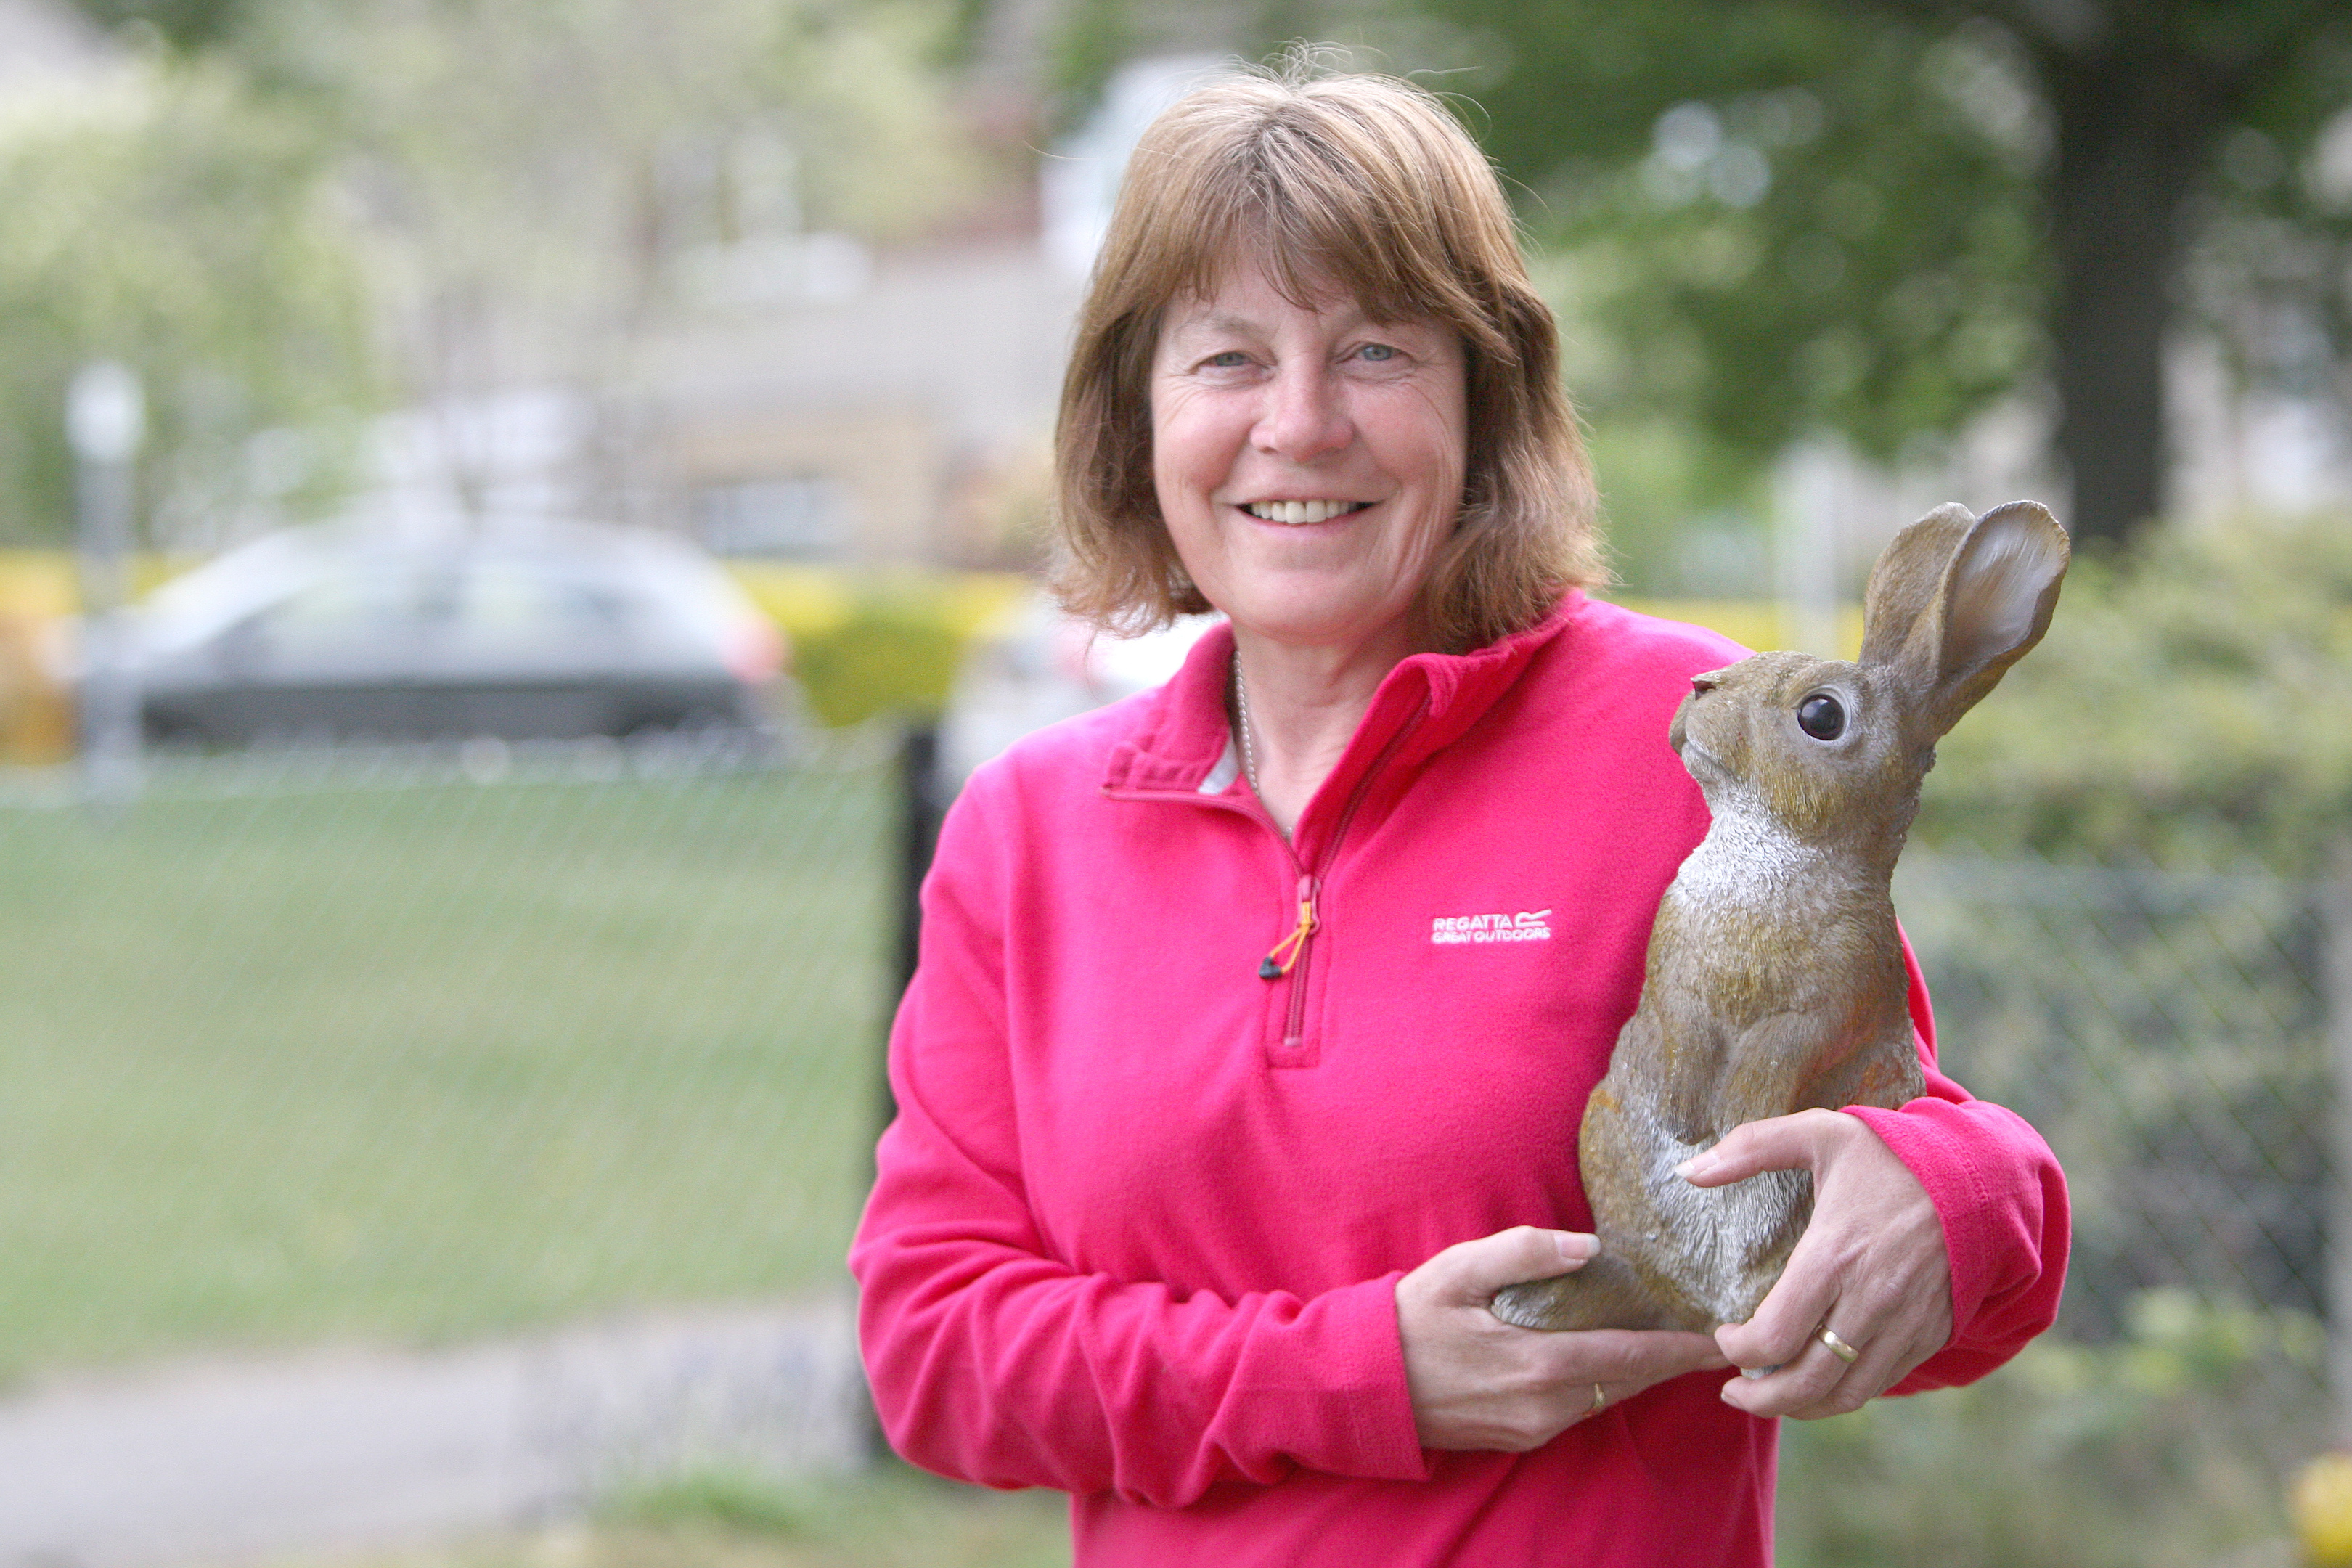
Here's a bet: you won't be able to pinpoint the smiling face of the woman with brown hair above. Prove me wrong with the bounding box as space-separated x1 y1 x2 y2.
1150 266 1468 658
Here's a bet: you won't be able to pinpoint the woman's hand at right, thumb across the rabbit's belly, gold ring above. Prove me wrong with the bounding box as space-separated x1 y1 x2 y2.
1684 1110 1952 1420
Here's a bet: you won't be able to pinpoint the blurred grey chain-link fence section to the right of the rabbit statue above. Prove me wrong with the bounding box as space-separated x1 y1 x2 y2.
1898 854 2331 1340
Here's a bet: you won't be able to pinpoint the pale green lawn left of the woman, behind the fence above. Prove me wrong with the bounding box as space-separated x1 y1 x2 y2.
0 769 891 1378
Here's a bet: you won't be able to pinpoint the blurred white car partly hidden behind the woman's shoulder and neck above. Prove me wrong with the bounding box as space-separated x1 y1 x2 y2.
939 592 1218 792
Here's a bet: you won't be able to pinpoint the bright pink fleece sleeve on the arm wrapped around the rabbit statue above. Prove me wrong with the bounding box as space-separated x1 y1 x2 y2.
1846 943 2067 1394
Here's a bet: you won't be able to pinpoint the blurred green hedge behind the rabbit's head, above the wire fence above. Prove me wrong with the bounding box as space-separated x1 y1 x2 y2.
1919 515 2352 875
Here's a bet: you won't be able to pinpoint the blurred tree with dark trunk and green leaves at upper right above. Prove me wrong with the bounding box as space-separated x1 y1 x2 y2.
1345 0 2352 550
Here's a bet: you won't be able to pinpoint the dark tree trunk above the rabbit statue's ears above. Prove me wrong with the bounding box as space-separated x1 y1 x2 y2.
2039 38 2230 543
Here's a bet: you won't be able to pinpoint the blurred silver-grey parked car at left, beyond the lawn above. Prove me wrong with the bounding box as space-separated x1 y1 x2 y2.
134 520 785 746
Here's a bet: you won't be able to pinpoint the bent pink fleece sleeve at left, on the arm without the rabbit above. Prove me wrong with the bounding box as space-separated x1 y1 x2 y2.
849 790 1428 1507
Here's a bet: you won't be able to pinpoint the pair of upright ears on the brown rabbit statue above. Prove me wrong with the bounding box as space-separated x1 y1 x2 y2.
1863 501 2067 736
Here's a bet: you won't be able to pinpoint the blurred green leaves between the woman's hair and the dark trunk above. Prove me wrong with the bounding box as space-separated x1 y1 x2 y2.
1392 0 2046 458
